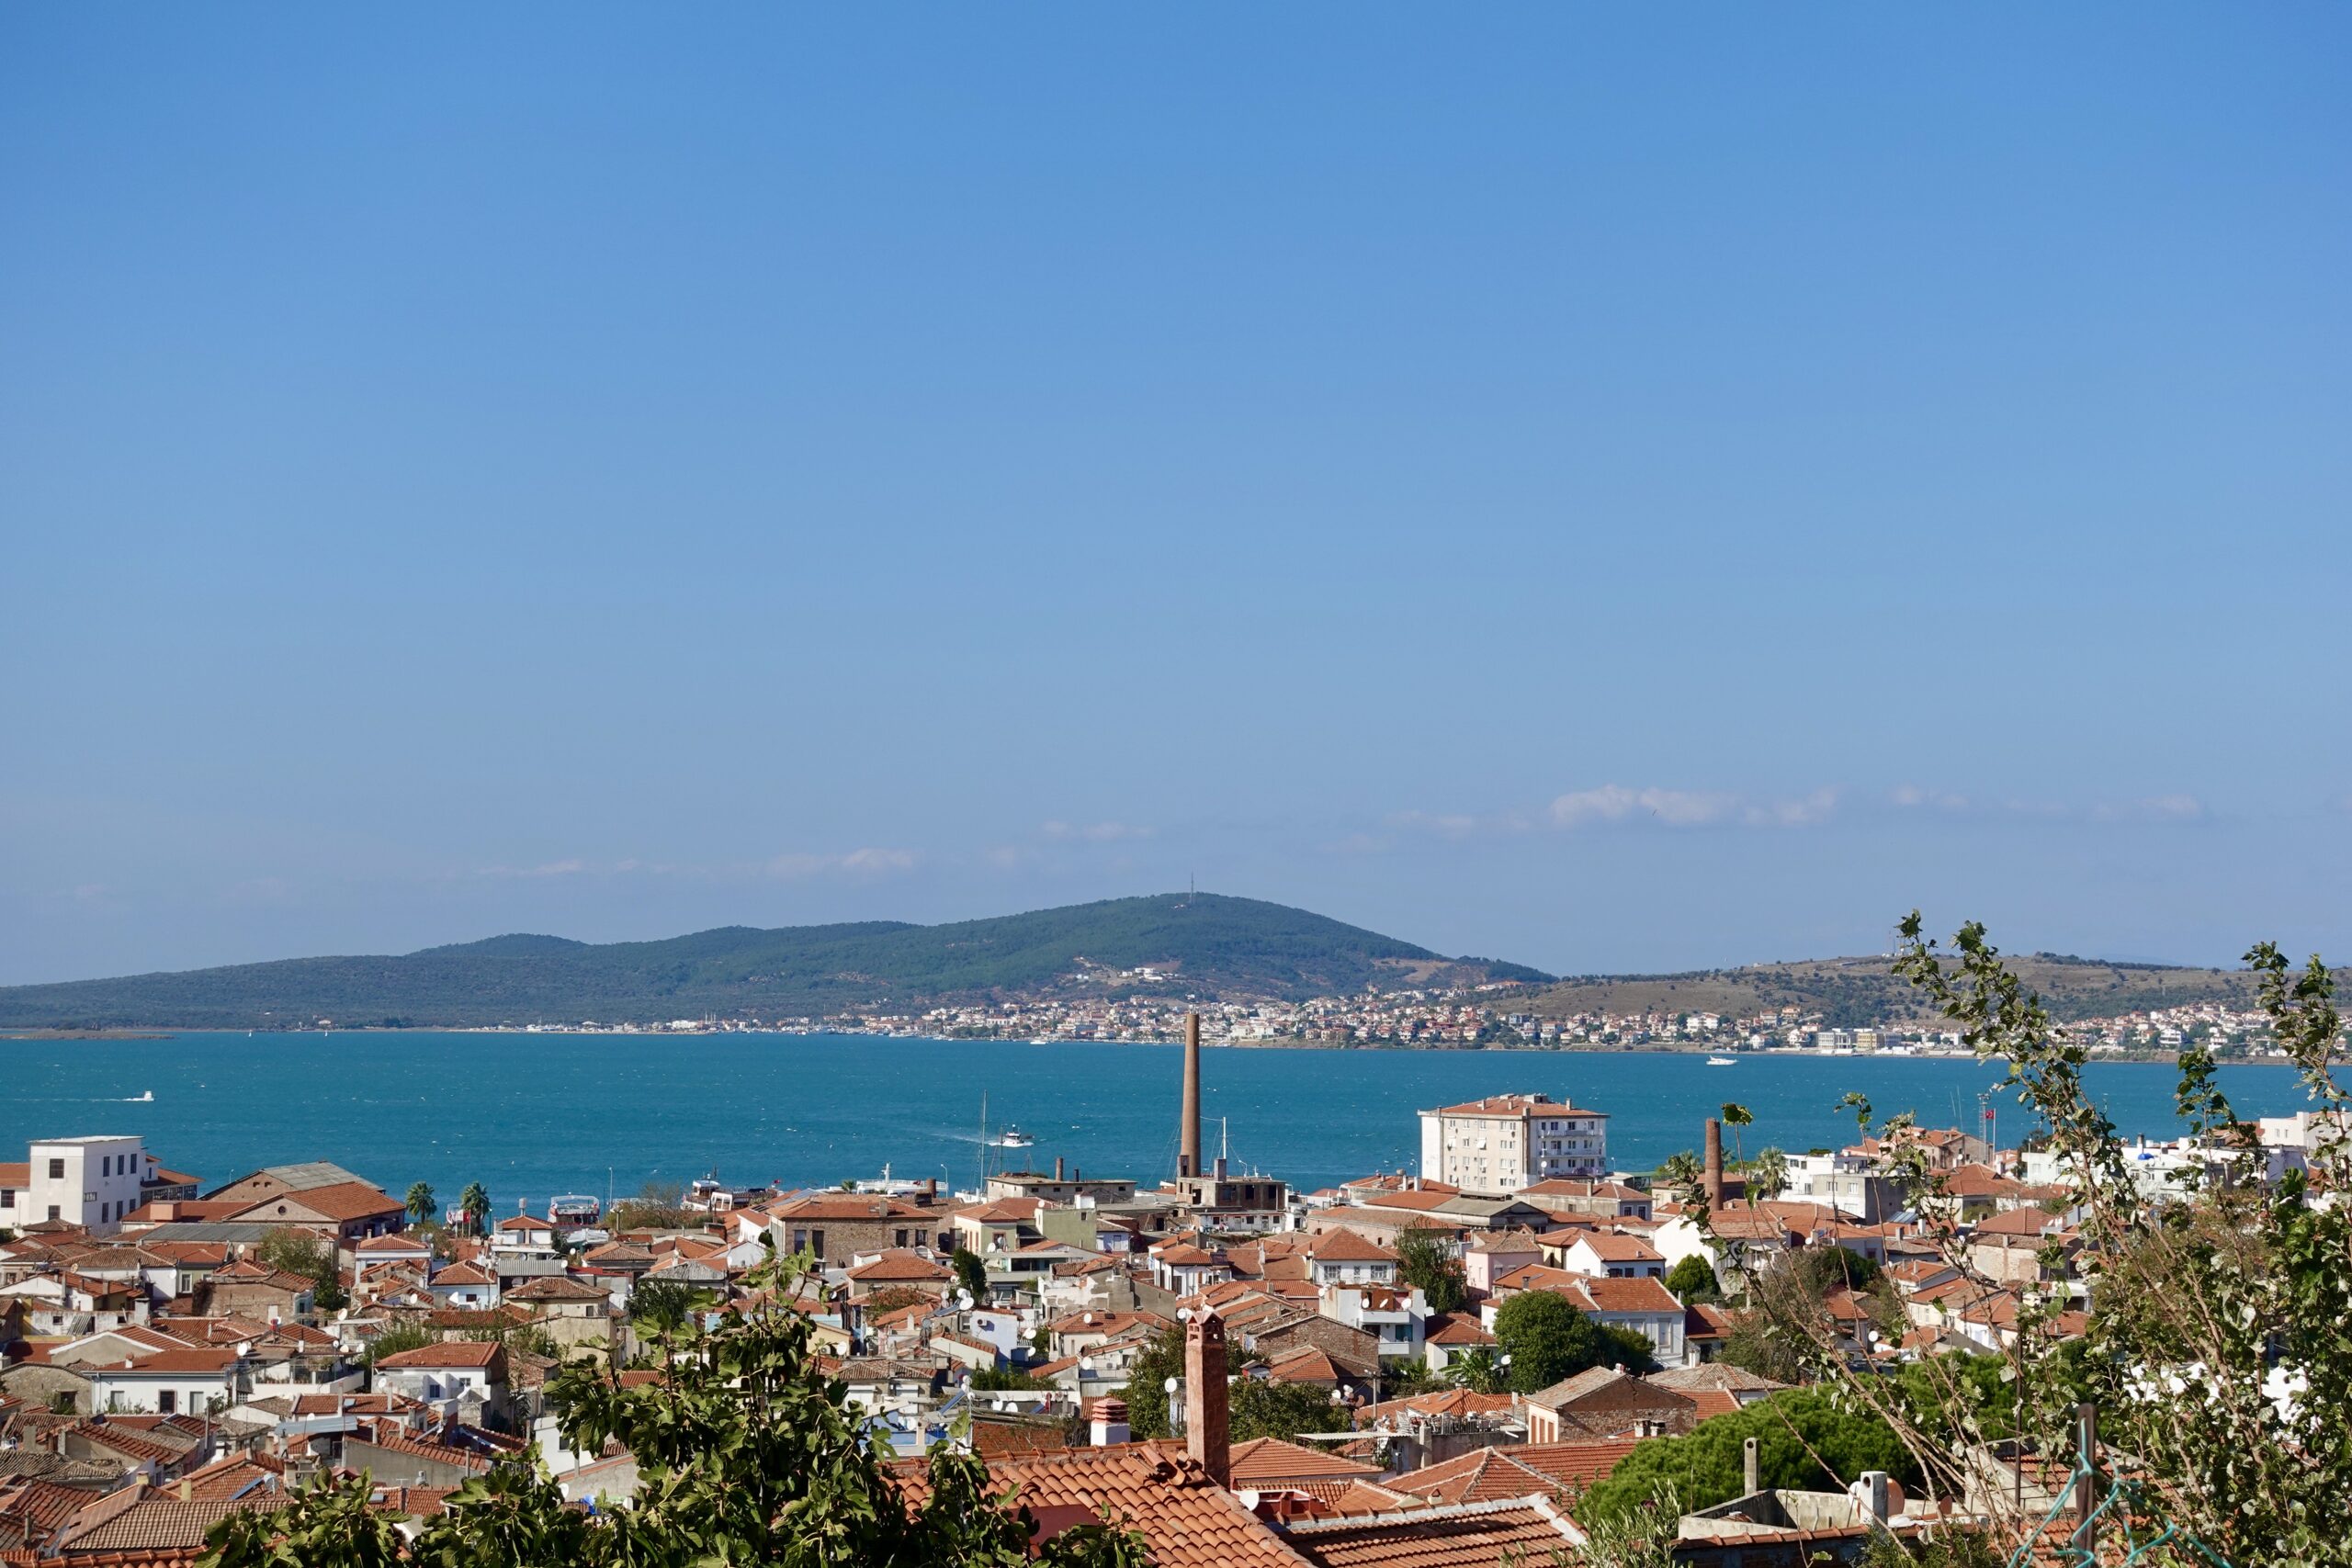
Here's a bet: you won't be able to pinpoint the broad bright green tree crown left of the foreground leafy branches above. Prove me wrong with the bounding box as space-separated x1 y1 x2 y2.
1576 1389 1919 1518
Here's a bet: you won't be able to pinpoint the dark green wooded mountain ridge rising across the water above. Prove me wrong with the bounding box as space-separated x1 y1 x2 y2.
0 894 1550 1030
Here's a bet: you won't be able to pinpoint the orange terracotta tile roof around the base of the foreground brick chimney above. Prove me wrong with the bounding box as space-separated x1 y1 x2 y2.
896 1446 1298 1568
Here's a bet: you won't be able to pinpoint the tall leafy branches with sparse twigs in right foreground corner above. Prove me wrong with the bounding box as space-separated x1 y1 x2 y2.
1740 912 2352 1568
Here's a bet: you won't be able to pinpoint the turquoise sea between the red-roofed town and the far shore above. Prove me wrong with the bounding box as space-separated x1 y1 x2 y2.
0 1032 2302 1213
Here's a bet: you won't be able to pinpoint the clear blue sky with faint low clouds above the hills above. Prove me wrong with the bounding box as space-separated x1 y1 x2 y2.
0 5 2352 983
